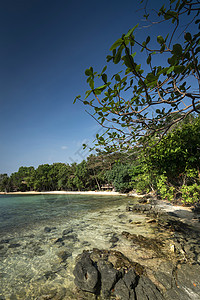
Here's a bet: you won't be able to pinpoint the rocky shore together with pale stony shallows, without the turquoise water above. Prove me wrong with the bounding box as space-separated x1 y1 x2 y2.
0 196 200 300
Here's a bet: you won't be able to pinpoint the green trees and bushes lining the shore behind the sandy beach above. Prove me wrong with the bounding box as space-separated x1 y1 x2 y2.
0 115 200 203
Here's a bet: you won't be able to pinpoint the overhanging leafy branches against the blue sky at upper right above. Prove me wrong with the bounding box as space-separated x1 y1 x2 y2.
75 0 200 151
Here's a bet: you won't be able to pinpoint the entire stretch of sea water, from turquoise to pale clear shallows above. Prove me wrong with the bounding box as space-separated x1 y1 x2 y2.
0 195 156 300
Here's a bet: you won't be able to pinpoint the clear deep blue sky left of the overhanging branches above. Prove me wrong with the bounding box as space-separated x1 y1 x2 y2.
0 0 168 174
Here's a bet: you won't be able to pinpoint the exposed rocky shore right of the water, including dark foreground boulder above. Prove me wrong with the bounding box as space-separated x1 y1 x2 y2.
74 196 200 300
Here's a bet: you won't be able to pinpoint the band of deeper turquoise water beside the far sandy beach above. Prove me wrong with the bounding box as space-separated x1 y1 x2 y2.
0 195 124 236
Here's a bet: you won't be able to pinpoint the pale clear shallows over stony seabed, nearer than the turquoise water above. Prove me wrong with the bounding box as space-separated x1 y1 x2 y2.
0 196 158 300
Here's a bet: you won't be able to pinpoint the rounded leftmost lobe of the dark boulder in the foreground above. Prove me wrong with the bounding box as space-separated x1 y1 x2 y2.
73 252 99 294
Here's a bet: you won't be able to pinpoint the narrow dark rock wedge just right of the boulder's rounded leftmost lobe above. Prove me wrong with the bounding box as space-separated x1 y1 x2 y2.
97 260 121 298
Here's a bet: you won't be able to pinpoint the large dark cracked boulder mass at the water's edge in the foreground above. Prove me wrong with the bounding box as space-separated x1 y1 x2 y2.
74 249 165 300
